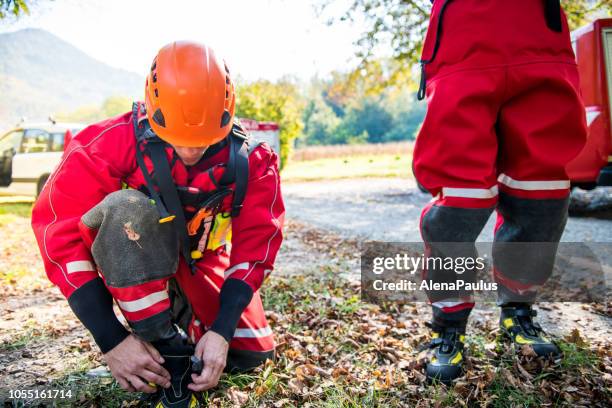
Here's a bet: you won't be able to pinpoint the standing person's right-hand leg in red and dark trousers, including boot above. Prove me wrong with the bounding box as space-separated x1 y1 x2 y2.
493 60 586 355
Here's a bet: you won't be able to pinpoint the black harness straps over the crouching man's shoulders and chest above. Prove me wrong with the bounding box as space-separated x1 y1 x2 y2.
132 103 249 273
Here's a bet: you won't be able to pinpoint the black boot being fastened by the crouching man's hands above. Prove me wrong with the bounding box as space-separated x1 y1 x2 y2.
146 341 201 408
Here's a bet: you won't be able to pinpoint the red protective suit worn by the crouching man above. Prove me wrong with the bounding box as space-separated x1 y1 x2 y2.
32 104 284 351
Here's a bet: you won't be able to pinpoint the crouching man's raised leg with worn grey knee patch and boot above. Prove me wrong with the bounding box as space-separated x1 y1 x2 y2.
80 190 196 407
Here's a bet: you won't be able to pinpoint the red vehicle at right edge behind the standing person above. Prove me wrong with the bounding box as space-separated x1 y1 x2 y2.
567 18 612 189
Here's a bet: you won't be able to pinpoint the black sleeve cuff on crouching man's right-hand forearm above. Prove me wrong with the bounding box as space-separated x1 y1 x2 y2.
210 279 253 343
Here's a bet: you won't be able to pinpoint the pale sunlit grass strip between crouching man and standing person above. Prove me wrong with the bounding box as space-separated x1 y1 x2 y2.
281 153 412 181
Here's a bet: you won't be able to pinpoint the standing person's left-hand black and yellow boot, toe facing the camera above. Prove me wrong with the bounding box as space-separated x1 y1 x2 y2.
425 326 465 385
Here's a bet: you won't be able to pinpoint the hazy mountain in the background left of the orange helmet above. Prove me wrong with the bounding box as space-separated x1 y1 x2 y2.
0 28 144 133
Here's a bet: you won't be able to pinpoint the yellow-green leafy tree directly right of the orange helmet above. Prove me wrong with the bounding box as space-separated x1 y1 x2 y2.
236 78 305 164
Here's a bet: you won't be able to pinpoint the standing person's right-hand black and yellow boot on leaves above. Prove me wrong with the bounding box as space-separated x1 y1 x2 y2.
499 303 562 361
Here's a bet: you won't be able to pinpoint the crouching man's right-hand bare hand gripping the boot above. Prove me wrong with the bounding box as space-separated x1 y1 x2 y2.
187 330 229 391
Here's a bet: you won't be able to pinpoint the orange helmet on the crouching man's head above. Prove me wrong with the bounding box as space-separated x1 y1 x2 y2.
145 41 236 147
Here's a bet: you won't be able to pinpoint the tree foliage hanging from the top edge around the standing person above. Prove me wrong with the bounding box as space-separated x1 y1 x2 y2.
320 0 612 82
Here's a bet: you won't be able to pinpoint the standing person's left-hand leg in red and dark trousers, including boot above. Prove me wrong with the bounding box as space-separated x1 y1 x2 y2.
413 69 504 381
